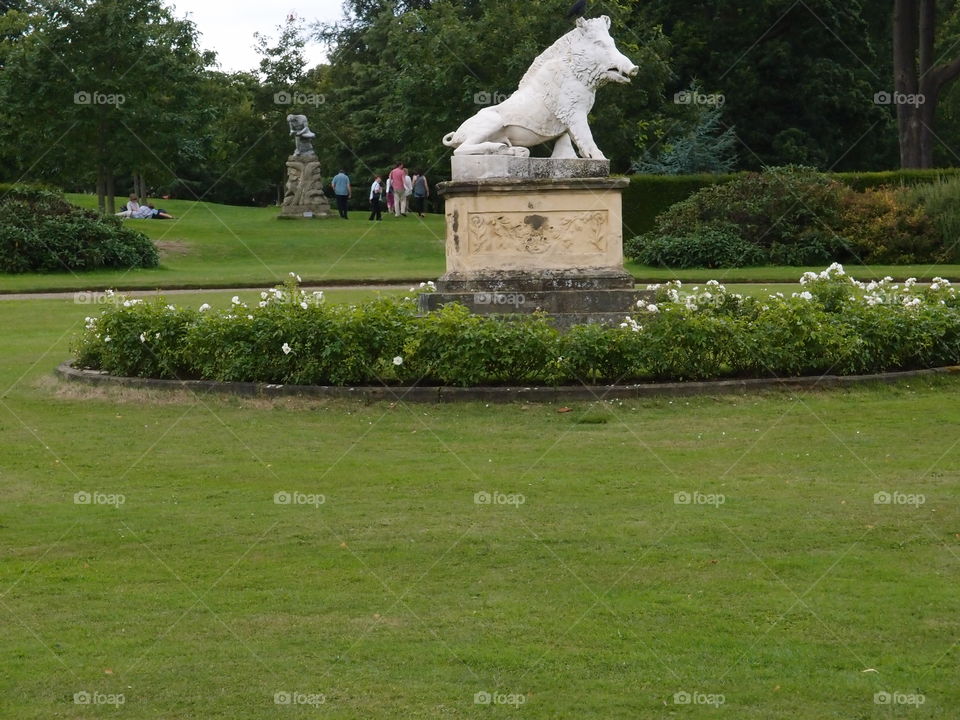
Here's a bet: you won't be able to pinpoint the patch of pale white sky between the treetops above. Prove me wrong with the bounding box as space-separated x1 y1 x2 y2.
167 0 343 72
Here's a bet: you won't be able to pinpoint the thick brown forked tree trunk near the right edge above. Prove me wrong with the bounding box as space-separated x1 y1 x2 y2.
892 0 960 168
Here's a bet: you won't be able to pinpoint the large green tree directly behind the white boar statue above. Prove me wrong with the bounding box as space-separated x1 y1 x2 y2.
318 0 669 177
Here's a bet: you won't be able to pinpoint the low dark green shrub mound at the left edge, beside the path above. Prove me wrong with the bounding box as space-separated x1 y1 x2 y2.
0 185 160 273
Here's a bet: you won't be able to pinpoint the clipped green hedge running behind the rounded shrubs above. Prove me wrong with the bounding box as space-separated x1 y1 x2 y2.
623 168 960 239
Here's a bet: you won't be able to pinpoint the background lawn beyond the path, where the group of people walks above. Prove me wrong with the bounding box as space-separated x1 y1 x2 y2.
0 195 960 293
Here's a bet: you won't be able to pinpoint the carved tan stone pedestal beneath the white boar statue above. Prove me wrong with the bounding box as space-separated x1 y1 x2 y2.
420 155 649 327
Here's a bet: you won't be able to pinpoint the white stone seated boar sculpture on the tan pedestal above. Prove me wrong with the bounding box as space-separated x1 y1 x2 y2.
443 15 639 160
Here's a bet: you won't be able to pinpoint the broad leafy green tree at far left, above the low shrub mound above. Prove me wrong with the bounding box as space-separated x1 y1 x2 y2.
0 0 213 212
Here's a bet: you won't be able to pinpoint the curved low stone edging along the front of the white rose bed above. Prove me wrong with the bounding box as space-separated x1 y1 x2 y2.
57 360 960 403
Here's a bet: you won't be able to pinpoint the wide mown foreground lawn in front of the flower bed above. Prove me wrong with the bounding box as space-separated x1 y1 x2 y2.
0 293 960 720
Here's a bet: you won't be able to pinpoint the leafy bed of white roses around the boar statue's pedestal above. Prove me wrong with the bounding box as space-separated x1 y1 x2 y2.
74 264 960 386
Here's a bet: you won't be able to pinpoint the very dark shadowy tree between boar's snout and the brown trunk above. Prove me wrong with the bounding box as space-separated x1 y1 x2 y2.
640 0 896 169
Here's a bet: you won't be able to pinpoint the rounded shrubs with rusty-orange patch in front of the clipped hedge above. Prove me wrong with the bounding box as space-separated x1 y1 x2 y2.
625 166 960 268
